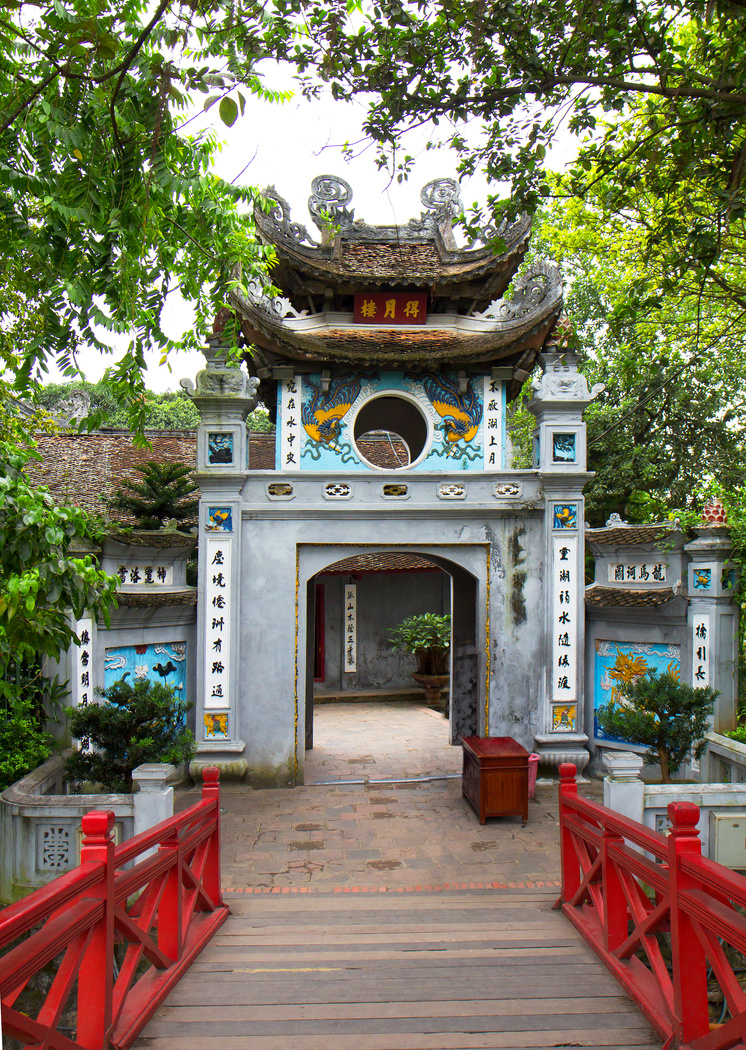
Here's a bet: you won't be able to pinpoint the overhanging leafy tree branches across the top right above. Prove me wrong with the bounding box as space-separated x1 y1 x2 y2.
294 0 746 270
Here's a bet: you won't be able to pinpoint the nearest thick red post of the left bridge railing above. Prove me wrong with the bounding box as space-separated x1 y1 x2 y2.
77 810 115 1050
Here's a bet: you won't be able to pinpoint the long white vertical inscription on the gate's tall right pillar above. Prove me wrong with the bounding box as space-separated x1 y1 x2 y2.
552 536 578 700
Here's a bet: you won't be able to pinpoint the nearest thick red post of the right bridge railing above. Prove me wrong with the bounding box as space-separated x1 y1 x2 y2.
668 802 709 1043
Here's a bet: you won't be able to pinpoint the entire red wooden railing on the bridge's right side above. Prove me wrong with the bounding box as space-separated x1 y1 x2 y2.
559 763 746 1050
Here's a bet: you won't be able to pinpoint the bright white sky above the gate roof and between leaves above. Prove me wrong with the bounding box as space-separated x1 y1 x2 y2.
51 86 572 392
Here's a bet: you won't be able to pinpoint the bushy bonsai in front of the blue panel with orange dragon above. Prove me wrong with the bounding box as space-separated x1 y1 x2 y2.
596 671 720 783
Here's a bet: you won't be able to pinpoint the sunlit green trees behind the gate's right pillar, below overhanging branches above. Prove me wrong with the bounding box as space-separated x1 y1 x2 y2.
534 194 746 526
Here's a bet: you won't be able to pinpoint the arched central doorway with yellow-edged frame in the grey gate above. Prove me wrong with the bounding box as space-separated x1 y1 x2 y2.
297 544 489 785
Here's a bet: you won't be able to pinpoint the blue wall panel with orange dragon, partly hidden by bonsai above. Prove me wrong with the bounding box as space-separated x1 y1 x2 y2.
594 642 681 743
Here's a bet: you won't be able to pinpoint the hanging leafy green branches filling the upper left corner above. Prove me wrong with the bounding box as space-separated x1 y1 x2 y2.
0 0 283 427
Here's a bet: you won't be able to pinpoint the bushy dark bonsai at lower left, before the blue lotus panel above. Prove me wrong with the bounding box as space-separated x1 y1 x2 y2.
65 674 195 792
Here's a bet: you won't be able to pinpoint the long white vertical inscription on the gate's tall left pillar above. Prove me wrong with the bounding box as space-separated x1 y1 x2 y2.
205 537 231 710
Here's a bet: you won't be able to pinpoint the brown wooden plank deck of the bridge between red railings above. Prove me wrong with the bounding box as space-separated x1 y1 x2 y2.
133 891 657 1050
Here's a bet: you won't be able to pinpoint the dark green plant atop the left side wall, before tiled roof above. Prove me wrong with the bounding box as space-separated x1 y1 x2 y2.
107 461 200 531
